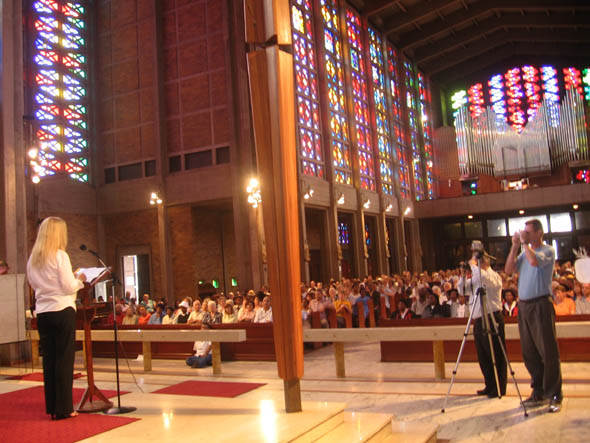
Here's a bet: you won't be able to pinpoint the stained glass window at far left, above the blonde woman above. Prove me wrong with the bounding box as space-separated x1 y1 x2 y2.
31 0 89 182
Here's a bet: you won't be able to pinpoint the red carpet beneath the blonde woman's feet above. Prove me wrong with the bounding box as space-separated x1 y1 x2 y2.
0 386 139 443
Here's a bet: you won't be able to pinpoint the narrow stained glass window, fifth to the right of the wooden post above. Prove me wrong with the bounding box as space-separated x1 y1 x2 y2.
387 44 411 199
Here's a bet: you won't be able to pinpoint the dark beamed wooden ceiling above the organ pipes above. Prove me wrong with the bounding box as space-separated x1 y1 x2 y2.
349 0 590 88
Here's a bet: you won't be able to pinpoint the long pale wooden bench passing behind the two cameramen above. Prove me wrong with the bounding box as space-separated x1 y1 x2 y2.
303 321 590 380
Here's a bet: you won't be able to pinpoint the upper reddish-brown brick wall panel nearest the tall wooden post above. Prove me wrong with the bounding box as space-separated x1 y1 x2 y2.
163 0 230 158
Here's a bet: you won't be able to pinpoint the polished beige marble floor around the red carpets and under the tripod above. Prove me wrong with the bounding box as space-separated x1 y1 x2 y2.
0 343 590 443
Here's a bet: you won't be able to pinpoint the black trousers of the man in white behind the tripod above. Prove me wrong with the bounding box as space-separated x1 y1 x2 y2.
473 311 507 395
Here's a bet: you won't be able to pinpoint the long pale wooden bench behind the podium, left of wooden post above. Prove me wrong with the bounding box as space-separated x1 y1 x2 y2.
27 329 246 375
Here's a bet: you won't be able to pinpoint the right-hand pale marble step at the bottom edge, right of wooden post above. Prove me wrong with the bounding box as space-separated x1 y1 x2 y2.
315 412 392 443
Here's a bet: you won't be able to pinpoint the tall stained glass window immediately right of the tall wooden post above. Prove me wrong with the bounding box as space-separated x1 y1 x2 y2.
291 0 324 178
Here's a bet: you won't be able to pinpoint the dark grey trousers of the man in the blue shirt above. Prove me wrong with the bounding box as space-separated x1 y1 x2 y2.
518 296 562 398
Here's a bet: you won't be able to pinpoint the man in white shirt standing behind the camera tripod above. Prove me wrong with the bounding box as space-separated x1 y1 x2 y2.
459 248 507 398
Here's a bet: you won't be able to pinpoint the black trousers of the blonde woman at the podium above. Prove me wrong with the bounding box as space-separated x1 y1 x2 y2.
37 308 76 416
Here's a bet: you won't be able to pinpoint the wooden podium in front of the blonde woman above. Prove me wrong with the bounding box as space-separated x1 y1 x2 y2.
76 268 113 412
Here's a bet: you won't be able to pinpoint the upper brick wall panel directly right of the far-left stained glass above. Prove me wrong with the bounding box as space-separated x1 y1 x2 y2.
97 0 156 176
